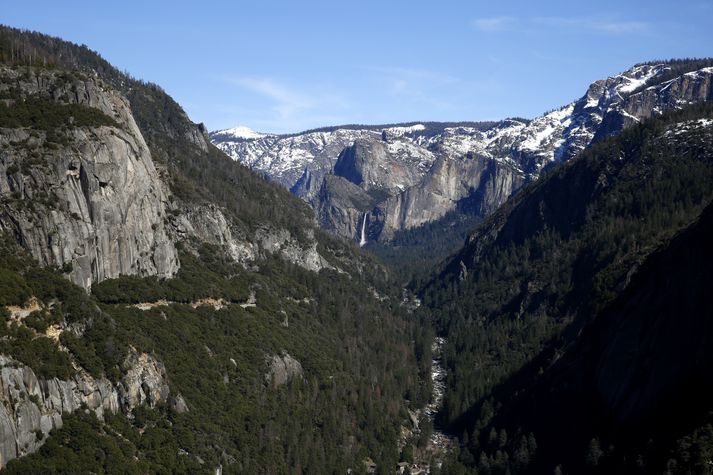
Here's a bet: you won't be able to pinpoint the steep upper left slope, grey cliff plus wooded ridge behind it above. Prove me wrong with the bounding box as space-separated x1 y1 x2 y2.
0 29 342 288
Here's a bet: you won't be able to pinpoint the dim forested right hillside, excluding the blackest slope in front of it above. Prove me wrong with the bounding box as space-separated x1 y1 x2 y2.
424 104 713 471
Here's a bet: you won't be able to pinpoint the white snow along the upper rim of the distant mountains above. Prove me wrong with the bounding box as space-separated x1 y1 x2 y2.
215 64 713 201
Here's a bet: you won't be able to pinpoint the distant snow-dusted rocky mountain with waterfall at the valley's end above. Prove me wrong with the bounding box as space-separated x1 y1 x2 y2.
210 60 713 247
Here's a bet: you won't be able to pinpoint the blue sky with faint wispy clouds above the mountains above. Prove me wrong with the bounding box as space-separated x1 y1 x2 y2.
0 0 713 132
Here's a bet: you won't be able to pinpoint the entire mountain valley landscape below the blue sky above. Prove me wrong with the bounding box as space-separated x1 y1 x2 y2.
0 20 713 475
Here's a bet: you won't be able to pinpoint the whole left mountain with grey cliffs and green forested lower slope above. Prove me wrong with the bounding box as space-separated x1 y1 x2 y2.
0 27 431 473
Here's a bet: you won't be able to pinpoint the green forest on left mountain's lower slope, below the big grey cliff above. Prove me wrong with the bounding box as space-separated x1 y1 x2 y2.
0 228 422 473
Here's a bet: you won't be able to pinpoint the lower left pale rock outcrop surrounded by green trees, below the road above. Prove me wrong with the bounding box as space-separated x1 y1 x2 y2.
0 350 177 467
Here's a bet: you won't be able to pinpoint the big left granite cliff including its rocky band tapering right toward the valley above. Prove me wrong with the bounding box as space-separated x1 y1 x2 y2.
0 67 338 290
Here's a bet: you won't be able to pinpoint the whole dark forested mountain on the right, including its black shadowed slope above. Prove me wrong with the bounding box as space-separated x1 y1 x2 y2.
422 99 713 473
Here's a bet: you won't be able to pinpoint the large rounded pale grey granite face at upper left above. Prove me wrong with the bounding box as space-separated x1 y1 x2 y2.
0 68 179 289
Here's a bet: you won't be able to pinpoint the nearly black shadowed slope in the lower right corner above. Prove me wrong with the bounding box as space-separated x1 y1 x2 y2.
494 199 713 473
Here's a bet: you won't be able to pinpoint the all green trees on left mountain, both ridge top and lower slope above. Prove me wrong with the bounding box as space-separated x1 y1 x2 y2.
0 28 432 473
